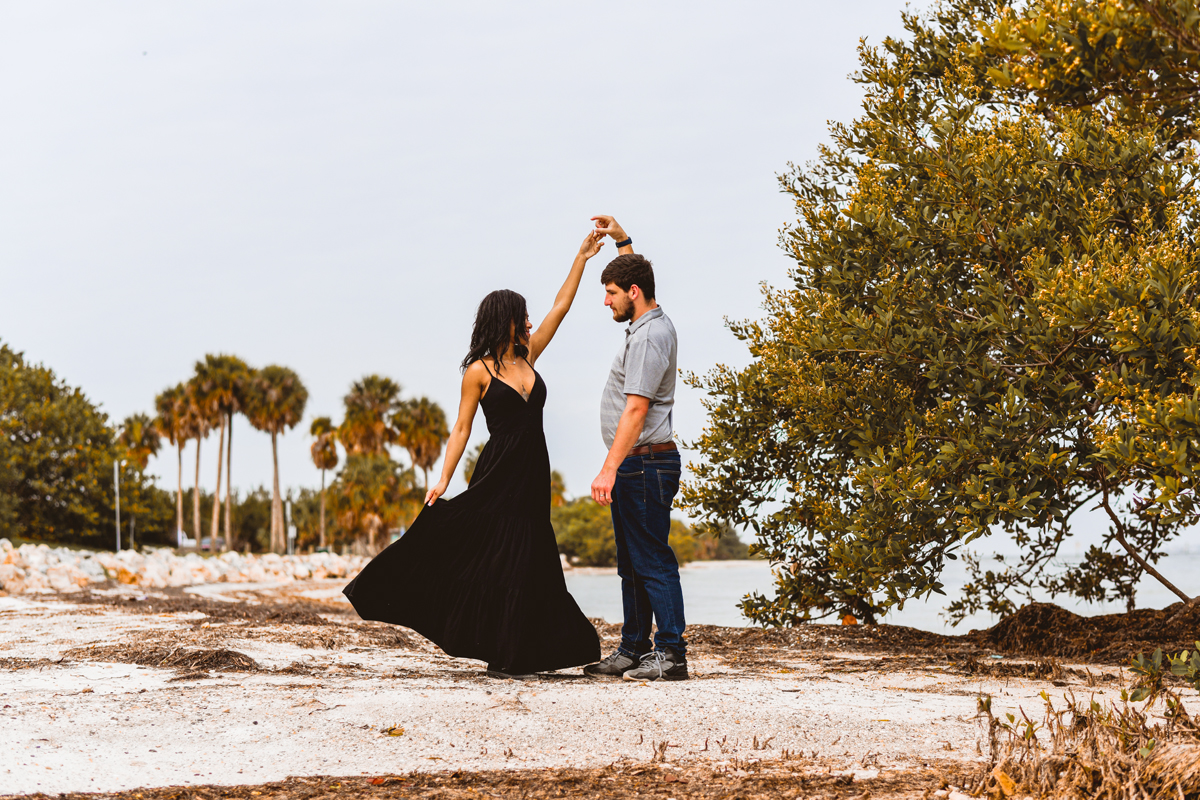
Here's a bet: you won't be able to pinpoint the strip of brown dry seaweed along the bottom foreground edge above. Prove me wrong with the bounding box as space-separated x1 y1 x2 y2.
0 762 967 800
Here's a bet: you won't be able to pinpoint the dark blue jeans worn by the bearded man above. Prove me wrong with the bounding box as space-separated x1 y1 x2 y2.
612 451 688 657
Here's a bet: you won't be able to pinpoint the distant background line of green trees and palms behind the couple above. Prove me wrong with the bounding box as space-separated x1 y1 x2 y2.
0 342 746 566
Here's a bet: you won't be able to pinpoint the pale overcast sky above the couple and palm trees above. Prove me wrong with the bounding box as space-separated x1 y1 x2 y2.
0 0 921 513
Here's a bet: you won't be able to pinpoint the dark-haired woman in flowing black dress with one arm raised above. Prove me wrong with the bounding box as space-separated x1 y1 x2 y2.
343 233 604 678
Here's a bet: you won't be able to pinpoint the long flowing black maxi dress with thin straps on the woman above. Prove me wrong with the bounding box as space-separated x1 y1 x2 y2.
342 362 600 673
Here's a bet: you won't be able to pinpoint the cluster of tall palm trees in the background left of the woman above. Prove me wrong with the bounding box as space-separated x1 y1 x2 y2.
150 355 449 553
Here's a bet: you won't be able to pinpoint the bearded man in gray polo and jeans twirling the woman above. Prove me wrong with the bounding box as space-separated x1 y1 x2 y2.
583 216 688 680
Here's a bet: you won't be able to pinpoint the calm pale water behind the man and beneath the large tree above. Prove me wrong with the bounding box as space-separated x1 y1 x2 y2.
566 553 1200 633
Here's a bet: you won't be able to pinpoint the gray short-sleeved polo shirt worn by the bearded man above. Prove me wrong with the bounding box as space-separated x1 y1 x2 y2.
600 308 679 449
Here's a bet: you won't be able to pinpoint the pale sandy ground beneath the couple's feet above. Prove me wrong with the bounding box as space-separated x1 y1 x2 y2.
0 582 1142 794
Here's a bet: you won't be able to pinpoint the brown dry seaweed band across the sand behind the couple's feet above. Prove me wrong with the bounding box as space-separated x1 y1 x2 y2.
65 590 1200 680
